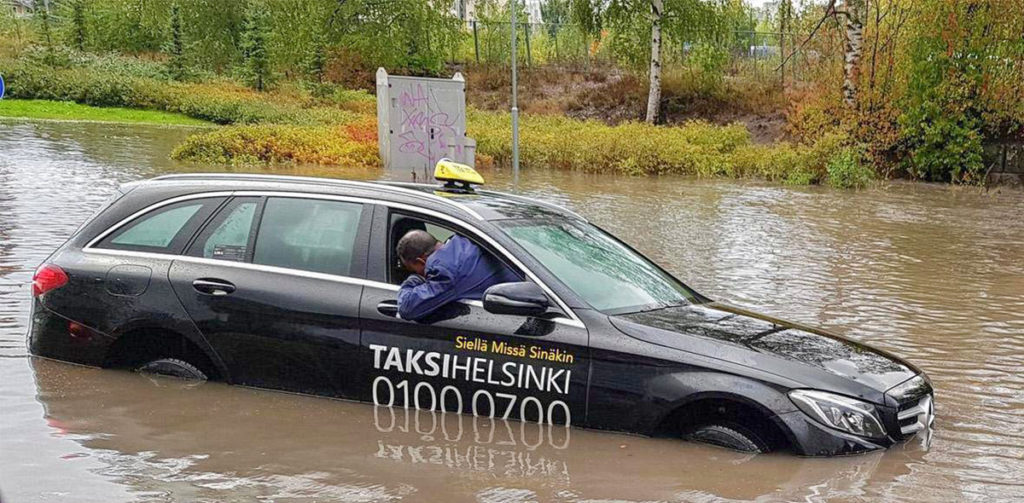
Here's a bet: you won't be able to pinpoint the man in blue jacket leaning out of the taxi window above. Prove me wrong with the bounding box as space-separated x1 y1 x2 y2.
396 229 521 321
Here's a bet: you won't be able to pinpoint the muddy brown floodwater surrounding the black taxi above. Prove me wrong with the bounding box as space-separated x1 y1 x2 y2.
0 121 1024 503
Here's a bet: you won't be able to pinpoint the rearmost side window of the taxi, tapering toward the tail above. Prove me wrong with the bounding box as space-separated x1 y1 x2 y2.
96 198 223 253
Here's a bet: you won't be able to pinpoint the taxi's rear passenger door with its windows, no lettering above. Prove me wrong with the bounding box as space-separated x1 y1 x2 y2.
169 195 371 397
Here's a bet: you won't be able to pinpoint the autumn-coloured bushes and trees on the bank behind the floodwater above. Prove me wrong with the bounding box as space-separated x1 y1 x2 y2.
0 0 1024 187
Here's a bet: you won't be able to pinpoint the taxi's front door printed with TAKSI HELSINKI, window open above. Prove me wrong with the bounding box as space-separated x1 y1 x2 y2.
359 208 589 425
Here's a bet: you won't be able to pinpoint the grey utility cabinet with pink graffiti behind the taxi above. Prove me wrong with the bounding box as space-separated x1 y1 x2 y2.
377 69 476 176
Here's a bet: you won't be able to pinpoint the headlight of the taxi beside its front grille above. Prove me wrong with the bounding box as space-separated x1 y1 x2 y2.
790 389 886 438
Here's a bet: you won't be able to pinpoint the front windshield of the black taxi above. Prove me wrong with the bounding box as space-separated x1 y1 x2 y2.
495 218 695 315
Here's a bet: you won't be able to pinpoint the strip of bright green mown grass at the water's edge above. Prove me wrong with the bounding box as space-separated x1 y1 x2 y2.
0 98 211 126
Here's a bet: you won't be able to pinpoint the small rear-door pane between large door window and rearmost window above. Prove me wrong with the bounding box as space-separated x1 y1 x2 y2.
188 198 260 262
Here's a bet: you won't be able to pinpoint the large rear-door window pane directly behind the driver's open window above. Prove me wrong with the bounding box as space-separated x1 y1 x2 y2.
253 198 362 276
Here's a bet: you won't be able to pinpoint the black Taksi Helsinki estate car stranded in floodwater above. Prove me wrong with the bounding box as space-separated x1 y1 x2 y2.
29 163 934 456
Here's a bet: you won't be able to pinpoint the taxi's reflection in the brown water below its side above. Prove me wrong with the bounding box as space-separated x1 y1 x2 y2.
33 360 905 501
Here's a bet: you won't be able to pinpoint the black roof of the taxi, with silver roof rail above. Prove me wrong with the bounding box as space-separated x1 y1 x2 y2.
142 173 584 220
